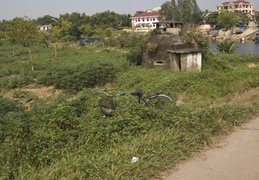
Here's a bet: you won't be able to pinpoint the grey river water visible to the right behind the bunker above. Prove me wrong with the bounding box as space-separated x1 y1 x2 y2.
210 41 259 55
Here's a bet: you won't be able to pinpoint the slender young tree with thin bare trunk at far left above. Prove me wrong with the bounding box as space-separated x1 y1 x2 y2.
7 18 38 71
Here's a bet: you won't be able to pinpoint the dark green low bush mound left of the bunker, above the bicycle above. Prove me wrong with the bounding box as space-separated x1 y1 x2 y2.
37 60 116 92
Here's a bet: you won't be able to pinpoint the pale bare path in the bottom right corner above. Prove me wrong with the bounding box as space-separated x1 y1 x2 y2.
164 117 259 180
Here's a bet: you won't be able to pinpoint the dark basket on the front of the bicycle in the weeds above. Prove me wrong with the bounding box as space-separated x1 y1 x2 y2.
99 99 117 116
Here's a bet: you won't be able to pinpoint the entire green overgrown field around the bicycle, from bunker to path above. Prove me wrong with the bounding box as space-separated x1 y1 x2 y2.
0 45 259 180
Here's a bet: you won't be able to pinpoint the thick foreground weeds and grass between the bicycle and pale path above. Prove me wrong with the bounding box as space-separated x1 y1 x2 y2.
0 97 255 179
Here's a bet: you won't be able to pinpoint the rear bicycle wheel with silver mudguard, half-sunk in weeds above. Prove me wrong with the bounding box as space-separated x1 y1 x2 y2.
144 94 174 112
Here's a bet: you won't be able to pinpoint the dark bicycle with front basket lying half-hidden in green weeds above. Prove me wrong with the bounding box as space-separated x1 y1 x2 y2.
99 89 173 117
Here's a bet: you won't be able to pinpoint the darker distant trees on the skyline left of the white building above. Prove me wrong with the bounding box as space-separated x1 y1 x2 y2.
0 11 131 40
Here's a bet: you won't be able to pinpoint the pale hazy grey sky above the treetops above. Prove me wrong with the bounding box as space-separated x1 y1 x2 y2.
0 0 259 21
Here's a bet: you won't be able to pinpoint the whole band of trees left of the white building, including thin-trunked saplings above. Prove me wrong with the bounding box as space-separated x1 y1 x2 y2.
0 11 146 71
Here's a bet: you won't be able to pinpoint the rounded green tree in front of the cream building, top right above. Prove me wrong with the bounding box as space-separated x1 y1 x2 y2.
218 11 239 30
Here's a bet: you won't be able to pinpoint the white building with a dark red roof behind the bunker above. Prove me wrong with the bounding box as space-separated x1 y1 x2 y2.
130 12 160 30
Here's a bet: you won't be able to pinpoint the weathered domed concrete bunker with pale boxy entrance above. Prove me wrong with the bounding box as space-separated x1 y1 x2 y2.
141 21 202 72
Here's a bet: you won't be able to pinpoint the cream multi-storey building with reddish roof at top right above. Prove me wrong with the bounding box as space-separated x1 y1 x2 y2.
217 0 255 16
